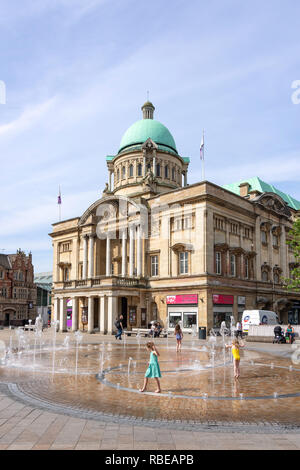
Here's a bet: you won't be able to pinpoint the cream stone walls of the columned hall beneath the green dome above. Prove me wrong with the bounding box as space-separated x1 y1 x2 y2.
50 103 300 333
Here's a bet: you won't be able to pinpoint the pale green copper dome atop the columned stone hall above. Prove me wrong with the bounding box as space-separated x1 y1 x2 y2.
119 119 177 153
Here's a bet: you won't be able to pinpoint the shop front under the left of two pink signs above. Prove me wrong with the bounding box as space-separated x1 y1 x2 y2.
166 294 198 333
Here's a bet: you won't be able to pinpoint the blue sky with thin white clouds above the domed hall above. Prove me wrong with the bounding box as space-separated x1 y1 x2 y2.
0 0 300 272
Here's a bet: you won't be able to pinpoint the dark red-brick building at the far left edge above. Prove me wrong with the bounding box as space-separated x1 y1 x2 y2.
0 250 36 326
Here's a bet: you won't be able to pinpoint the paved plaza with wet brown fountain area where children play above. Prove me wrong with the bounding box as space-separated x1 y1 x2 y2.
0 329 300 450
